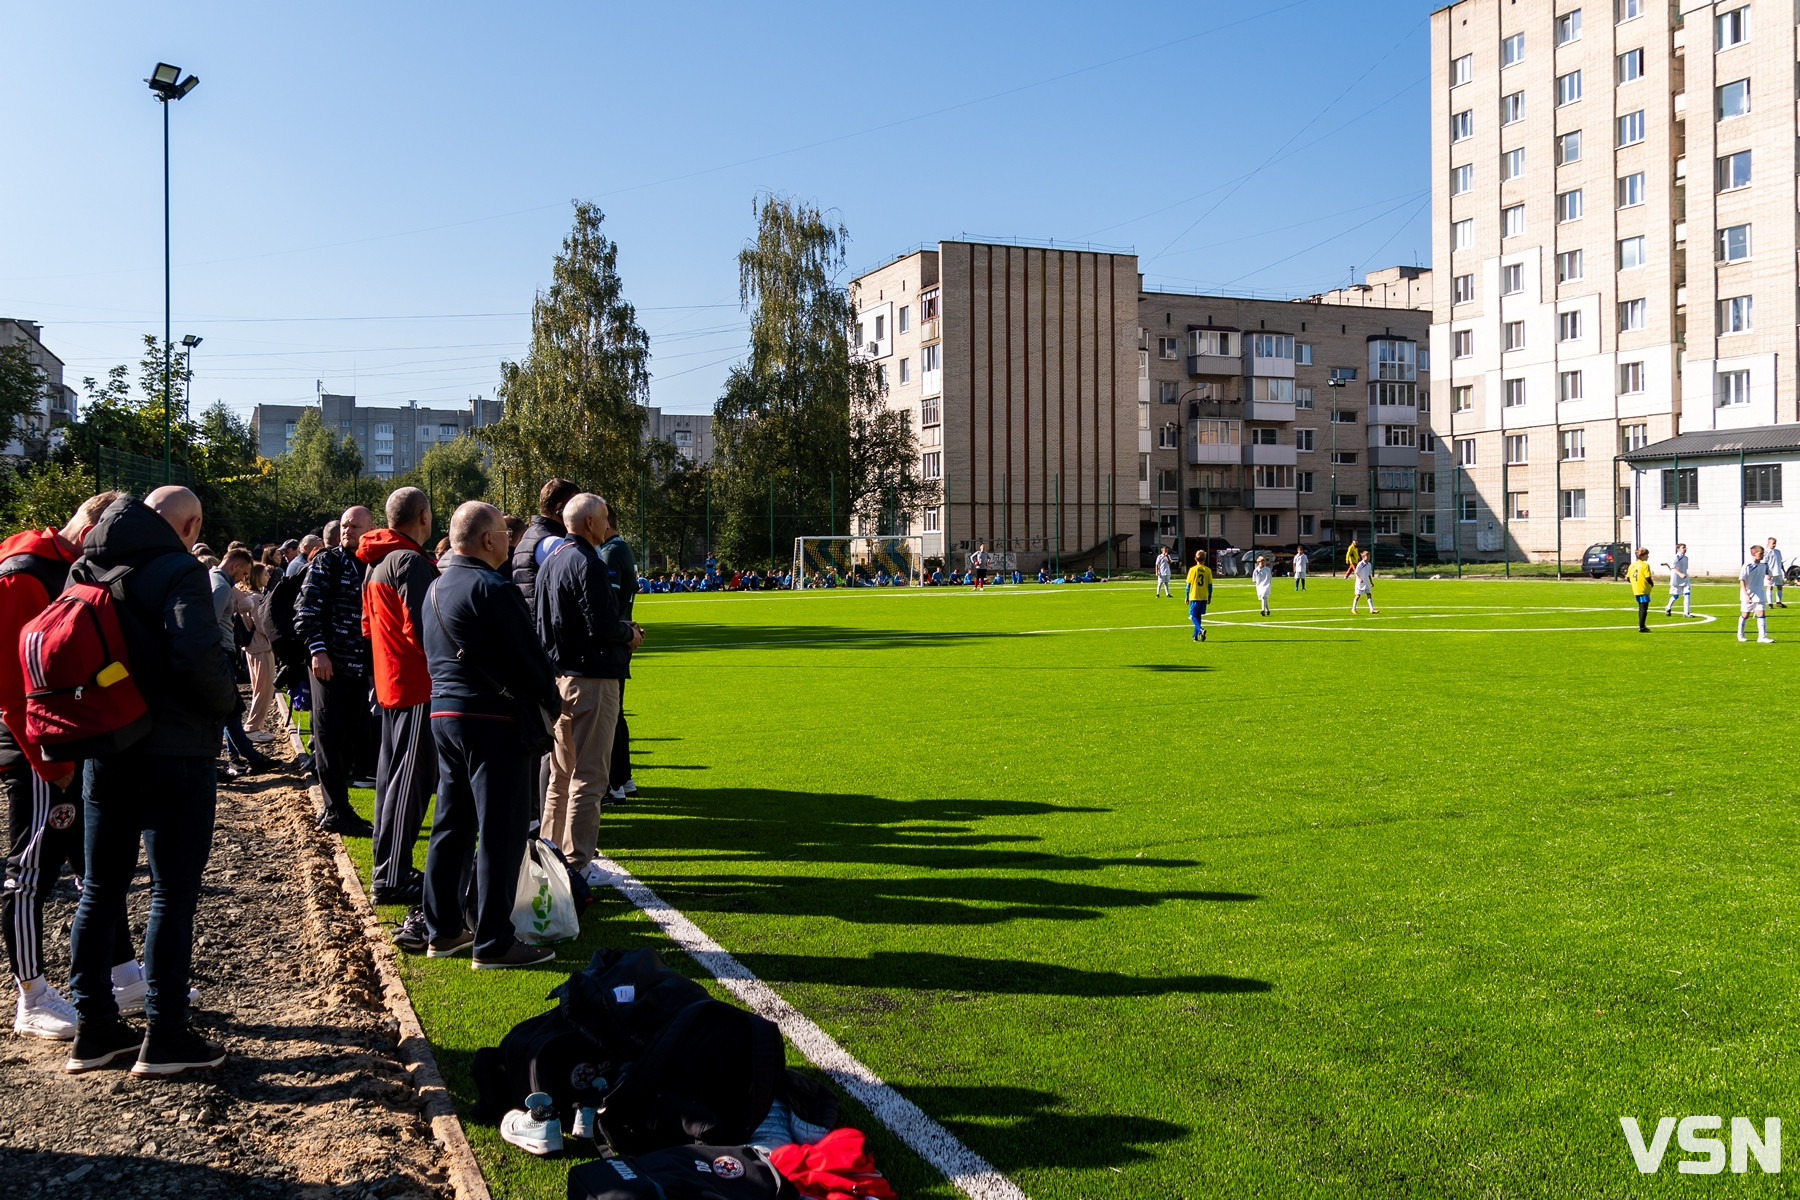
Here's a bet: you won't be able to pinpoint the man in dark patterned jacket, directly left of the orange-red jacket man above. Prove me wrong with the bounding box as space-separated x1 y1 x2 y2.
293 504 374 838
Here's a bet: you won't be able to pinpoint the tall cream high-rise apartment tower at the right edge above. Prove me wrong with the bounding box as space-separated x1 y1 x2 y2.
1431 0 1800 560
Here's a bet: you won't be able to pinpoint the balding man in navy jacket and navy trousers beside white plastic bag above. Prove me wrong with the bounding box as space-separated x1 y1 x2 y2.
423 500 562 970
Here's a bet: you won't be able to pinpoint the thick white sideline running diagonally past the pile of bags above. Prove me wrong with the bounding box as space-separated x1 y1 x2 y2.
594 855 1030 1200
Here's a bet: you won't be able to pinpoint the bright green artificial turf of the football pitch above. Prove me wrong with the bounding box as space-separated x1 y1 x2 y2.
340 578 1800 1200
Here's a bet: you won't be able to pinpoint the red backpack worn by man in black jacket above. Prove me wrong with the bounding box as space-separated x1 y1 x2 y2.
18 563 151 763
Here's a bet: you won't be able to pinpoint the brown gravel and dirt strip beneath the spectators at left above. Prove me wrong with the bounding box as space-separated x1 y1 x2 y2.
0 741 452 1200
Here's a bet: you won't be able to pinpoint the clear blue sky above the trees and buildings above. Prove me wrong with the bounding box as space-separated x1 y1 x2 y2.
0 0 1431 422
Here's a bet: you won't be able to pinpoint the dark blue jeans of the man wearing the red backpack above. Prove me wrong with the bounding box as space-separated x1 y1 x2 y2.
68 748 218 1029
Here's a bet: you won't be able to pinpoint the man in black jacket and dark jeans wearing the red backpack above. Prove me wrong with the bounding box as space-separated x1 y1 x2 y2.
63 488 238 1076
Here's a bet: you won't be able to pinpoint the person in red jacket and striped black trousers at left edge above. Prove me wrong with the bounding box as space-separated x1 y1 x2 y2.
0 491 146 1040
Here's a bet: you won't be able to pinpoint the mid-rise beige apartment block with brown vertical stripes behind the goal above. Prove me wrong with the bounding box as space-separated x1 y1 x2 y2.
853 241 1436 570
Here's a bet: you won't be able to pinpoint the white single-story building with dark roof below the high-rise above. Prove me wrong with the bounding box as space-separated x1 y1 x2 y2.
1618 423 1800 576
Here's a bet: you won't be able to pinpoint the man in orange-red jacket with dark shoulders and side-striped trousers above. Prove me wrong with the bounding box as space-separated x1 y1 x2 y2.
356 488 437 905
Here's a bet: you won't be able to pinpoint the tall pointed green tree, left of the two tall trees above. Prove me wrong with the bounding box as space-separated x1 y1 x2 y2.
477 201 650 510
